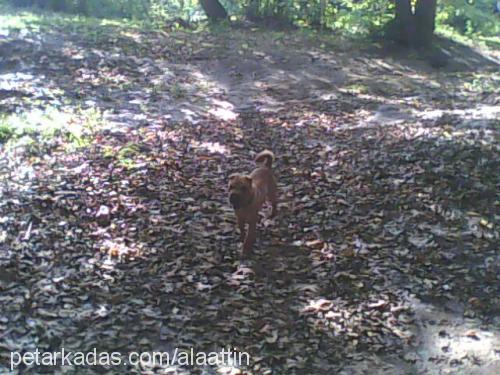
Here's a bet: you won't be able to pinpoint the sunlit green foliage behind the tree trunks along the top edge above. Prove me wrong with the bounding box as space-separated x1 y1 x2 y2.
4 0 500 36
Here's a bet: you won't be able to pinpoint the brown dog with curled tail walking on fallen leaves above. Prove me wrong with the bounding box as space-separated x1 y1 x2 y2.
229 150 277 257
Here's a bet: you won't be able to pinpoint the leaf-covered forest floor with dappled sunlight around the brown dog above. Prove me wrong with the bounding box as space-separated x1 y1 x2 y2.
0 8 500 374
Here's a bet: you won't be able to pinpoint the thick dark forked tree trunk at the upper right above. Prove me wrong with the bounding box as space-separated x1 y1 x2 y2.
391 0 437 47
